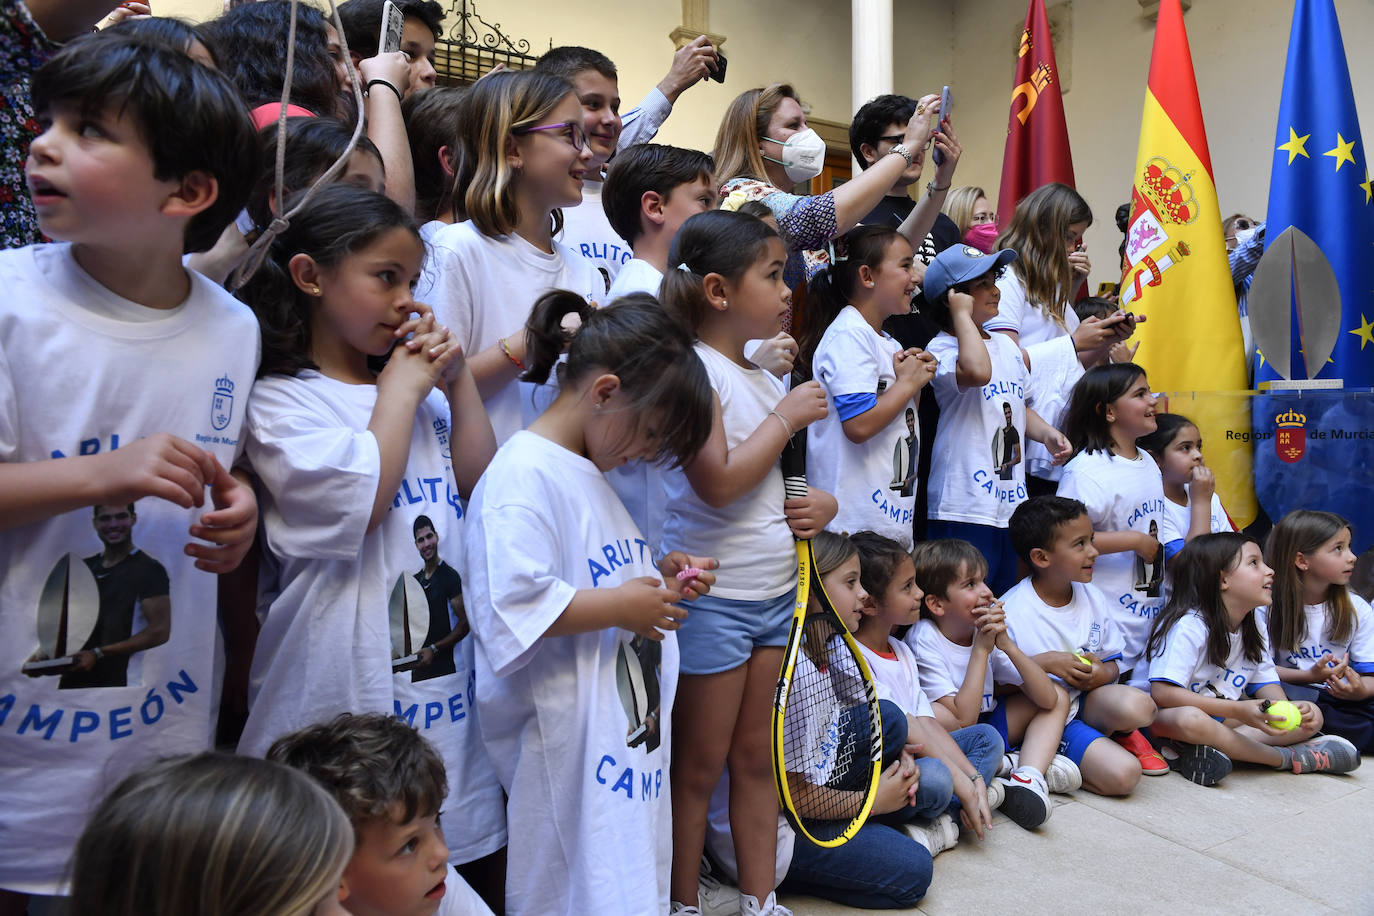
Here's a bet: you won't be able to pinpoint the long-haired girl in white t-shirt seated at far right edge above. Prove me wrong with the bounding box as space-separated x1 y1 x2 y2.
1265 509 1374 753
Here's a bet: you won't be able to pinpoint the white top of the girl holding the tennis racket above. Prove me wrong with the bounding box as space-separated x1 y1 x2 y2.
662 343 797 601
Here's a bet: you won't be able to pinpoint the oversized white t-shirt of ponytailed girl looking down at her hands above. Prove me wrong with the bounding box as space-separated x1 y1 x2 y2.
464 431 677 916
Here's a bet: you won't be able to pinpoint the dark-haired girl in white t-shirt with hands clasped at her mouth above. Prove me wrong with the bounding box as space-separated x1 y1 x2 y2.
239 184 506 864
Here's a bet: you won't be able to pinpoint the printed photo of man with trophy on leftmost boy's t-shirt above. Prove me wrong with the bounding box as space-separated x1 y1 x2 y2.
22 503 172 689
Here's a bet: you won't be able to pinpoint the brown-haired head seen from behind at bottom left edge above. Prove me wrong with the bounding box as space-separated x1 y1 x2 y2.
70 754 353 916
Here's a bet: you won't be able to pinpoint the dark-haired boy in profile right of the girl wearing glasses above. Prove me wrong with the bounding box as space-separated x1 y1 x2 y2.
600 143 716 301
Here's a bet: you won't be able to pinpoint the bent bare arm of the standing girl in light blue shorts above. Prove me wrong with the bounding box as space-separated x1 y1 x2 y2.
683 382 826 508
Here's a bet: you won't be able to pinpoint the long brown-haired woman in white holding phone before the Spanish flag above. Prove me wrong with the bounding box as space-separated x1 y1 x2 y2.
982 184 1145 496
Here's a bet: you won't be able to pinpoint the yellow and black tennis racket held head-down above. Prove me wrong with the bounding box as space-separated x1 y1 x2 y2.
772 430 882 846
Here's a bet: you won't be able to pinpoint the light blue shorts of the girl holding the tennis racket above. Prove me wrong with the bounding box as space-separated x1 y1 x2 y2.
677 589 797 674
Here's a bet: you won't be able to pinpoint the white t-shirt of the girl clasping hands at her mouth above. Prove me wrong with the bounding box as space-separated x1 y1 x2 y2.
239 371 506 864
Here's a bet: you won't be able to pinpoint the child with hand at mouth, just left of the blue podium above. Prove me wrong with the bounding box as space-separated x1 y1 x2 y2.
1136 413 1235 566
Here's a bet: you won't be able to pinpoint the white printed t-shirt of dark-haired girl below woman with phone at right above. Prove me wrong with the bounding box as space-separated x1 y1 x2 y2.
1059 449 1168 673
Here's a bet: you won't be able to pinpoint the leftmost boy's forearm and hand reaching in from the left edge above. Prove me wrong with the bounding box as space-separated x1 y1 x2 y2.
0 433 217 529
